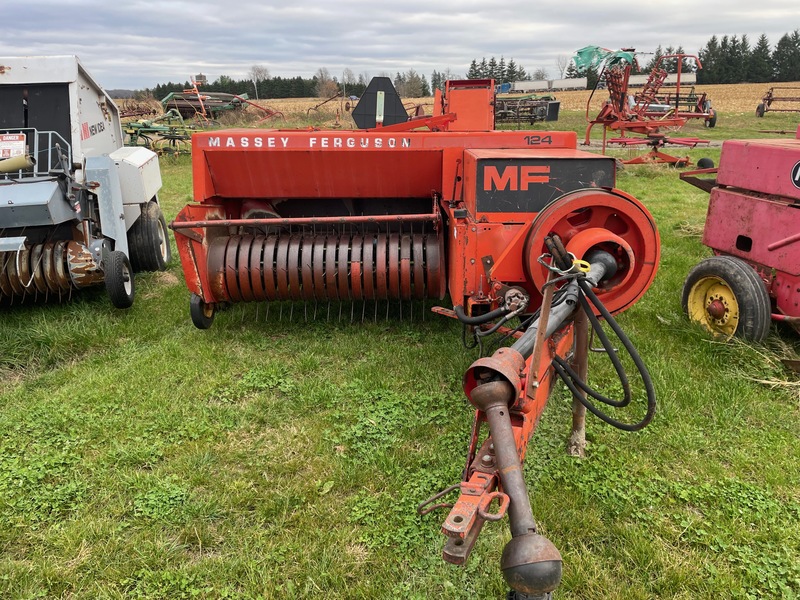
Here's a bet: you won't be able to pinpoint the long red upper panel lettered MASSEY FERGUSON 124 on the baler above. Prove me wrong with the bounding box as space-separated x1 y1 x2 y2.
192 129 577 202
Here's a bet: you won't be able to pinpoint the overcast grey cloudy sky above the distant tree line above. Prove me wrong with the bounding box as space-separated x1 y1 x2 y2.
0 0 800 89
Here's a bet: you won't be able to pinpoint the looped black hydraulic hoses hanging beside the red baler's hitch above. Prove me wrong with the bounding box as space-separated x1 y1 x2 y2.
553 279 656 431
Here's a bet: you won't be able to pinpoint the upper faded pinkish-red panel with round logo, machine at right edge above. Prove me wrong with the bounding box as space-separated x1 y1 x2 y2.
717 139 800 200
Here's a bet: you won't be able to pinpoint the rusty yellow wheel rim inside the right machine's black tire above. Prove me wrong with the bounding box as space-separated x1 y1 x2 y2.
687 277 739 340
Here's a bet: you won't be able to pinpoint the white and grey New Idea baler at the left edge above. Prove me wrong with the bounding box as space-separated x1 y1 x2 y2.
0 56 170 308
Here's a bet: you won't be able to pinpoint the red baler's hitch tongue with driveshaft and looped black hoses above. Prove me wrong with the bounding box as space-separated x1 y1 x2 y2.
419 235 655 596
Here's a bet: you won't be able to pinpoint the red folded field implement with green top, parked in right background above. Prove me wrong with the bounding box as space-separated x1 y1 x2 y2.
574 46 717 166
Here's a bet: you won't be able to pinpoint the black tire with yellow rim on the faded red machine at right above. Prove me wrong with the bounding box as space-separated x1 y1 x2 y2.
681 256 771 342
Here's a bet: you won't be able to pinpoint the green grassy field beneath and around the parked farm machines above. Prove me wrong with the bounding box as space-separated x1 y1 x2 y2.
0 85 800 600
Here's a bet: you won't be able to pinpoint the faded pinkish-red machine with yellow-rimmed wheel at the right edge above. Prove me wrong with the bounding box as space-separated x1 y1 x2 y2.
681 127 800 341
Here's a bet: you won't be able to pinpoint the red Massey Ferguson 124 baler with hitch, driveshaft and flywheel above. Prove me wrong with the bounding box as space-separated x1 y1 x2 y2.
170 81 659 598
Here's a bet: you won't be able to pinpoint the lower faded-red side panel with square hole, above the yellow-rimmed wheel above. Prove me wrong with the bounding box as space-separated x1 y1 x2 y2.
703 188 800 275
